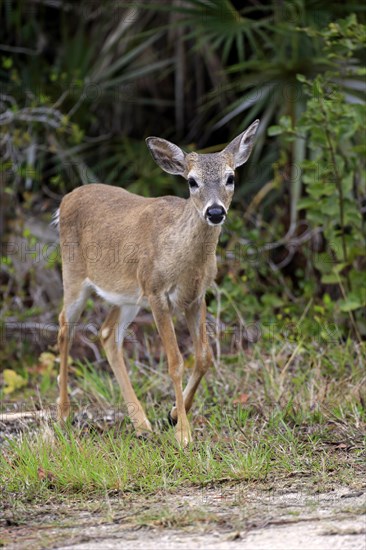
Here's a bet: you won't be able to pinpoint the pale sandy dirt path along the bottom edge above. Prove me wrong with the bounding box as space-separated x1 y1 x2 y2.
0 481 366 550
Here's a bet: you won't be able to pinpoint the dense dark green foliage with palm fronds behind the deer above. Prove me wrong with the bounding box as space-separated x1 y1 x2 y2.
0 0 366 376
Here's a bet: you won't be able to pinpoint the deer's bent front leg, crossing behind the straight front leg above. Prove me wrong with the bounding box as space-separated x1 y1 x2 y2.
170 299 212 423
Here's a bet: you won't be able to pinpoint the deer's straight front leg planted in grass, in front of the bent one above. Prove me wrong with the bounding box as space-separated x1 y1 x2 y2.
149 296 192 447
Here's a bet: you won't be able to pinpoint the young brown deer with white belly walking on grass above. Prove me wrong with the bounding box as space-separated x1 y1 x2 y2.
57 120 259 447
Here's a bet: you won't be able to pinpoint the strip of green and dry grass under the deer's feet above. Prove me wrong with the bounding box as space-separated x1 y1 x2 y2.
0 341 366 502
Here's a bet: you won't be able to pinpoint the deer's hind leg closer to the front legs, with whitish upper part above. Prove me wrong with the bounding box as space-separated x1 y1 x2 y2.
100 305 152 435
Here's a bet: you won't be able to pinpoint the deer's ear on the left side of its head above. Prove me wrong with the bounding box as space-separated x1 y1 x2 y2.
146 137 186 176
